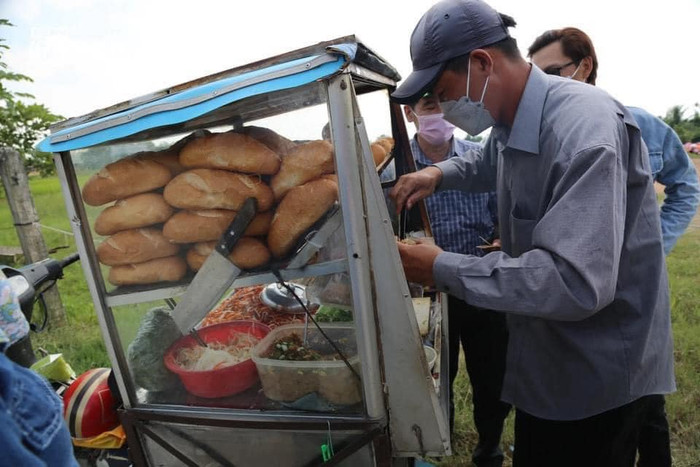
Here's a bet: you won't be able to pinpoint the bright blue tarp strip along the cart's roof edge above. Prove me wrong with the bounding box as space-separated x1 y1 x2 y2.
37 44 357 152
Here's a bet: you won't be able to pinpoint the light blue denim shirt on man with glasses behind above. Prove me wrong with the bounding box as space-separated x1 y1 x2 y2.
628 107 700 255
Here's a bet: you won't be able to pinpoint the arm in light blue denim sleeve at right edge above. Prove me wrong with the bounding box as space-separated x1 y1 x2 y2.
642 127 700 255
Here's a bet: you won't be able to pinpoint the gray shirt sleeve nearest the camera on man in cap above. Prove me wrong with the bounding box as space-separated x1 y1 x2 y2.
433 145 627 321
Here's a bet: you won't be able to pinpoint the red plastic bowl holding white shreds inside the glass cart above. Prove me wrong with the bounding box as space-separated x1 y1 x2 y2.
163 321 270 399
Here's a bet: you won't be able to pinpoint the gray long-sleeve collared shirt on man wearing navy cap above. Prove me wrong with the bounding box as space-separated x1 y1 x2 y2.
434 67 675 420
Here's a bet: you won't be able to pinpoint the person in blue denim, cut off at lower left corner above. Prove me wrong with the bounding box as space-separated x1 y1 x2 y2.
0 273 78 467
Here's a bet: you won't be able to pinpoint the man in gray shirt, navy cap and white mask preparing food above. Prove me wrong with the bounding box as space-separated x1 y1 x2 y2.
391 0 675 466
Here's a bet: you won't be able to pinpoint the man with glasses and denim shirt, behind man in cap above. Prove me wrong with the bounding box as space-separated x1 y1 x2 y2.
528 27 700 255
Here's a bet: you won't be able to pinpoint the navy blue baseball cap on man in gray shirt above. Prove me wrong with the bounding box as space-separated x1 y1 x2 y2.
391 0 510 104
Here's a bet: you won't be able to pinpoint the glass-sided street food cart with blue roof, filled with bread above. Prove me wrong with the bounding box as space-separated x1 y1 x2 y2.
40 36 450 466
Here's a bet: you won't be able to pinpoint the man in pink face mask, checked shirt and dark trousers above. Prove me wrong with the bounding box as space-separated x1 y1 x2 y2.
404 94 510 467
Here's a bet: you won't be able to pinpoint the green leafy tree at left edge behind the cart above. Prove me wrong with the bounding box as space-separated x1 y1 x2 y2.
0 19 63 176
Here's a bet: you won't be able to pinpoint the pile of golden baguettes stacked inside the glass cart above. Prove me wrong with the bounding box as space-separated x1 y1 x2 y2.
82 126 393 285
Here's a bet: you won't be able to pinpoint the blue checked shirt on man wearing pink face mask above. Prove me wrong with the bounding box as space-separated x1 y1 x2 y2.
411 136 498 256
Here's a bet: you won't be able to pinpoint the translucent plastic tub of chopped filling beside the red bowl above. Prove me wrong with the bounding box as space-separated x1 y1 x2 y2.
253 323 362 405
